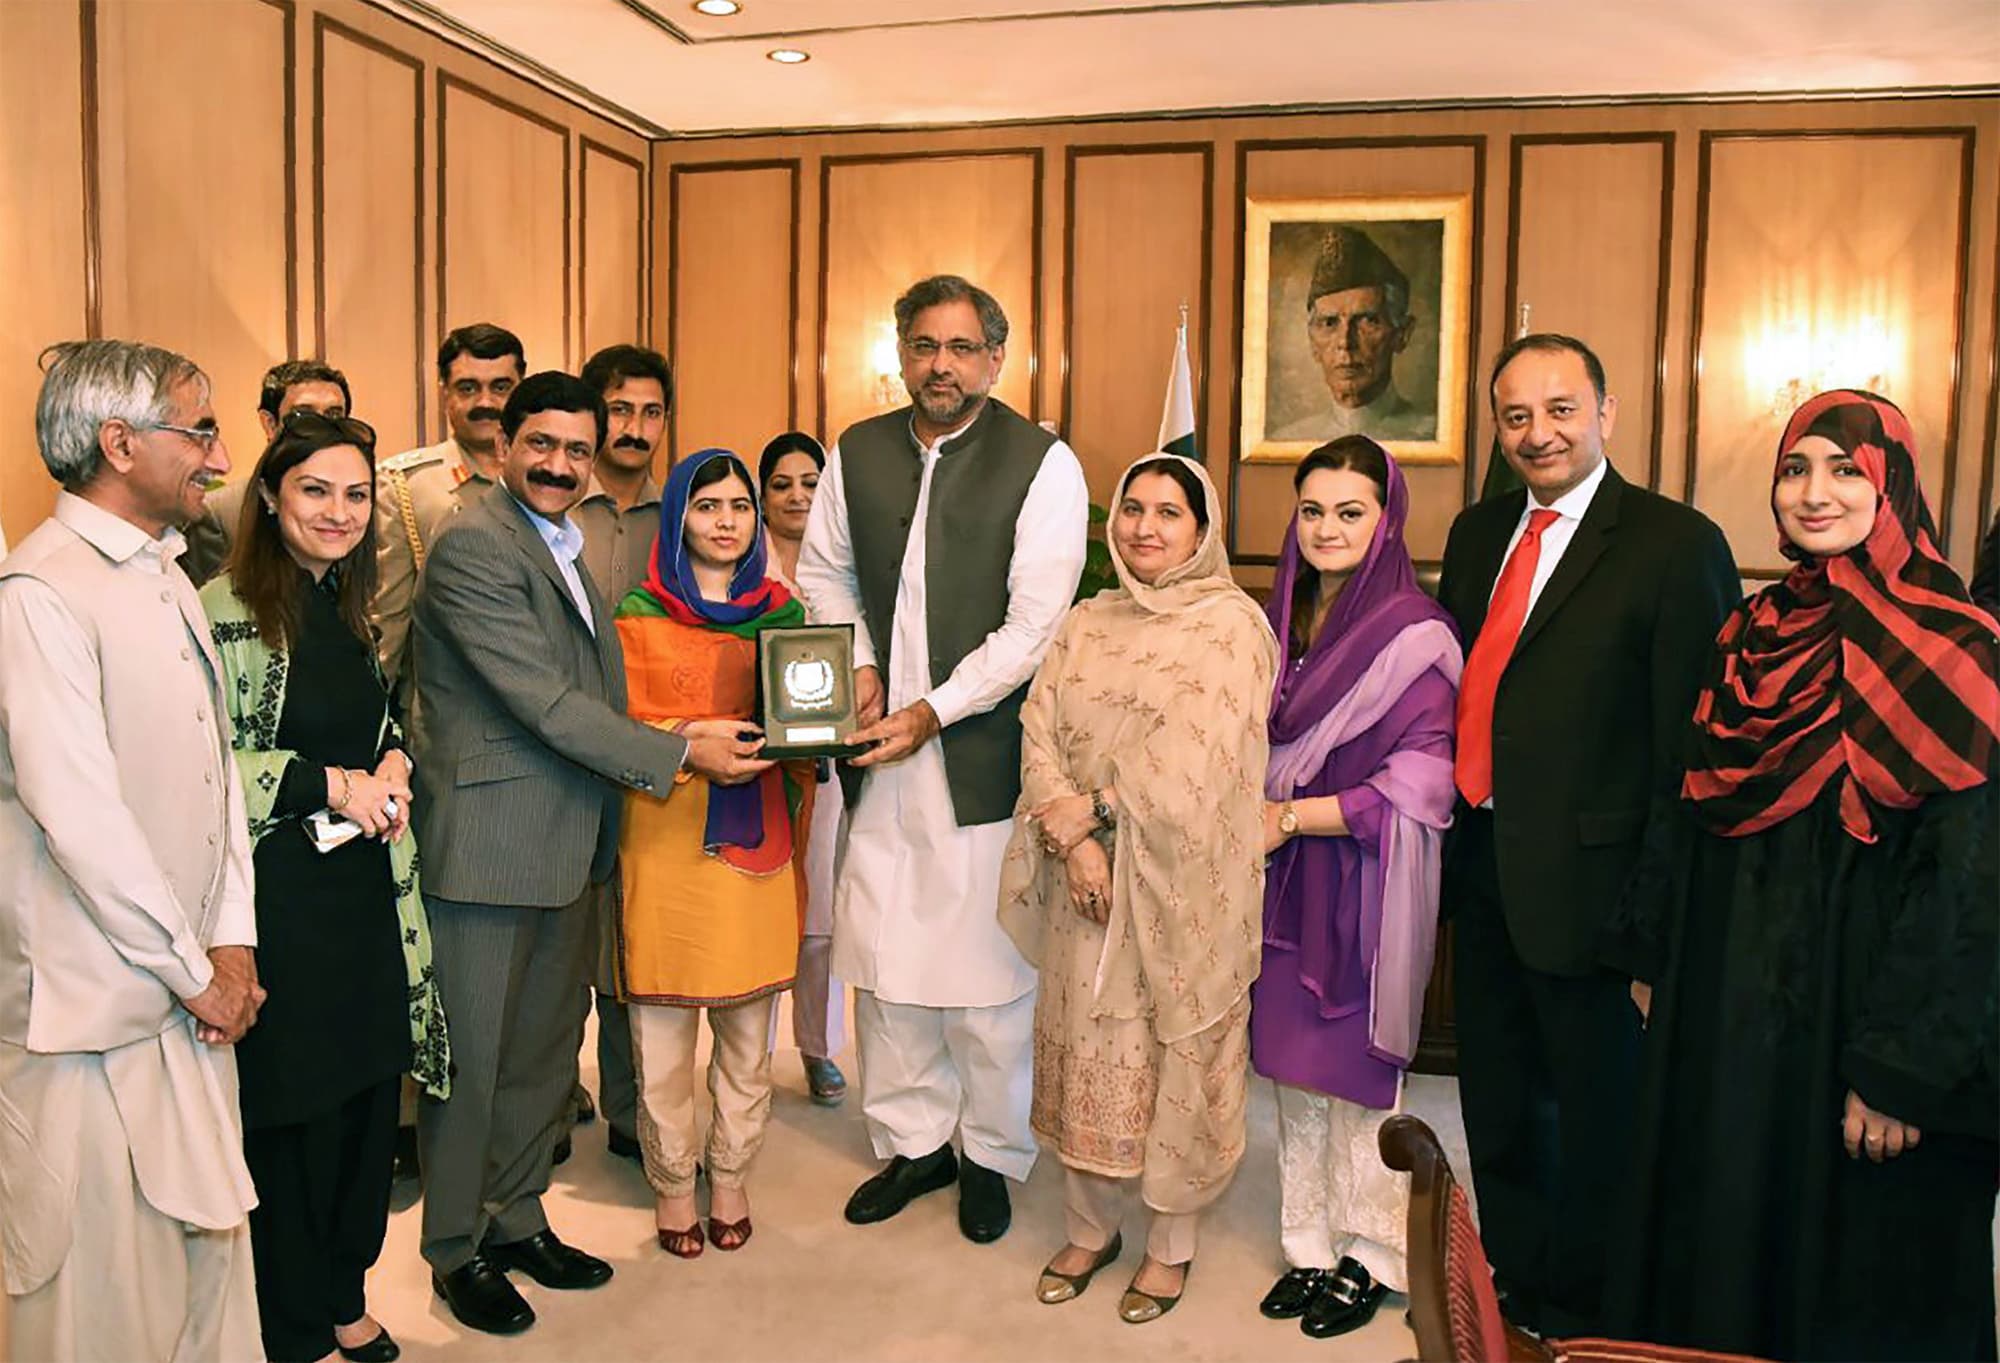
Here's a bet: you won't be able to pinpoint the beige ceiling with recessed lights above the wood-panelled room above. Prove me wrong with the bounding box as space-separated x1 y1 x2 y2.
376 0 2000 136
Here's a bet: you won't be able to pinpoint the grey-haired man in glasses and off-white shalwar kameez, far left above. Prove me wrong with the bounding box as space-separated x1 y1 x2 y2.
0 340 264 1363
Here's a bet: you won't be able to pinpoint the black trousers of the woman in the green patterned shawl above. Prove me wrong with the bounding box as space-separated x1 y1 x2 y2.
244 1075 402 1363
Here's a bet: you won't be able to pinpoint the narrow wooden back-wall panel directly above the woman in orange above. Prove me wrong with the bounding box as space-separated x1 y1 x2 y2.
668 160 800 466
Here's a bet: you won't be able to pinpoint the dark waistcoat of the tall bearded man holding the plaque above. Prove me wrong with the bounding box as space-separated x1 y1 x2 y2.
840 387 1056 827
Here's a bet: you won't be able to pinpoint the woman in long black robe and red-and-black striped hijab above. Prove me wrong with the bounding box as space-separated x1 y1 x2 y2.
1612 392 2000 1359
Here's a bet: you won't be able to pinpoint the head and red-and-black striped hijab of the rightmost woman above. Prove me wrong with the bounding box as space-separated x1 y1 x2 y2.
1684 390 2000 841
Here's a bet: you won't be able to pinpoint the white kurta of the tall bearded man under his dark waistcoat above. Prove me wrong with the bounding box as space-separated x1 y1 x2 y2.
798 422 1090 1007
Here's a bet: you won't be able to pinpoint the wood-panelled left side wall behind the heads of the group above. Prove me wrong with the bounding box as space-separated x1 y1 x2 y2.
0 0 652 538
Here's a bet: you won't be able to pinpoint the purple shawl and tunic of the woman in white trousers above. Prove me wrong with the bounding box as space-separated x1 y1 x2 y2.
1252 460 1462 1101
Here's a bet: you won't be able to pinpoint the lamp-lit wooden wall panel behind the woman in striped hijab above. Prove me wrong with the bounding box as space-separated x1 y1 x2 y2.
1684 130 1972 576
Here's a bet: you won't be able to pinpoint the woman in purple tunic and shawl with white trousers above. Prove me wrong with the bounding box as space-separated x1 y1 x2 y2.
1250 436 1462 1339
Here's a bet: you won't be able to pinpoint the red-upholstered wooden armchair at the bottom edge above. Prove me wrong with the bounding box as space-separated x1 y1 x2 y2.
1380 1115 1758 1363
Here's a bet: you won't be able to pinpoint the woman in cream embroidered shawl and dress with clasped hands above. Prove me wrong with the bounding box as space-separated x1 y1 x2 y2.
1000 454 1276 1325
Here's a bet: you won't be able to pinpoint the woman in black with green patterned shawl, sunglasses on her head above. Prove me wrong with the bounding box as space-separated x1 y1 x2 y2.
202 414 450 1363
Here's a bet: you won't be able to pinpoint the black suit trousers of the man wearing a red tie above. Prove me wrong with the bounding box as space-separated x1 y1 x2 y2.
1446 809 1642 1333
